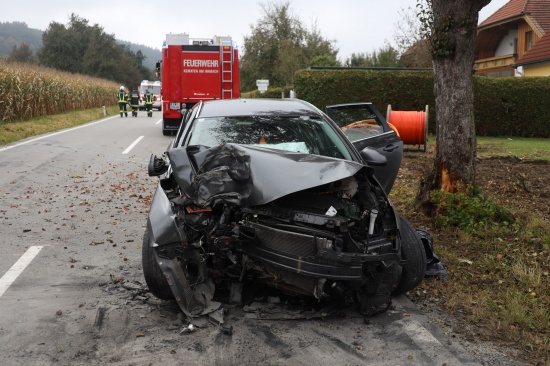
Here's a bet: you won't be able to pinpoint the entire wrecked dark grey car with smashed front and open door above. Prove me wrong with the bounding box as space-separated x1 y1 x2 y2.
142 99 442 317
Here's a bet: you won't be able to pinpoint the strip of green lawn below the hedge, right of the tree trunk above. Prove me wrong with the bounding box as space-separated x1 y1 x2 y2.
477 137 550 160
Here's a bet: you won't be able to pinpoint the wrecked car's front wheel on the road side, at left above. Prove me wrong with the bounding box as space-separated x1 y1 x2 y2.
141 224 174 300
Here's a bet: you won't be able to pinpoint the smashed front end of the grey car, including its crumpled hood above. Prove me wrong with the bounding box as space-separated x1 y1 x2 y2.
146 144 403 316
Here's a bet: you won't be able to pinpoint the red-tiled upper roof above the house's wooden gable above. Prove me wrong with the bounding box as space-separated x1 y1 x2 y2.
478 0 550 34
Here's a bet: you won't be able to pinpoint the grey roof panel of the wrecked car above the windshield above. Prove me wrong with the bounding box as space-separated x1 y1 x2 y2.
197 98 322 118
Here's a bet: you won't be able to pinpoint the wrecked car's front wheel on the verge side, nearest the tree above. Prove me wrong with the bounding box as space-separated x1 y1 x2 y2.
392 216 427 295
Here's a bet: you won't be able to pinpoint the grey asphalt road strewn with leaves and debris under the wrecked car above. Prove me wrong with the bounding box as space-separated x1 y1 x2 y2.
0 111 518 366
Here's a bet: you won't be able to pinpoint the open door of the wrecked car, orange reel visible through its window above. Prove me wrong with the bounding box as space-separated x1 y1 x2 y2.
326 103 403 194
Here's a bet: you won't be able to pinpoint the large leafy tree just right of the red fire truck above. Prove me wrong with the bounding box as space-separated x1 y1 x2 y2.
240 1 338 90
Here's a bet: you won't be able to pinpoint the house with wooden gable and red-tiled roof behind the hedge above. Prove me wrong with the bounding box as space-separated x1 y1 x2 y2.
474 0 550 76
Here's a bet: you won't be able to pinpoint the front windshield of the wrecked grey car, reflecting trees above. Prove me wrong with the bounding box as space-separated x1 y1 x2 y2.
187 116 352 160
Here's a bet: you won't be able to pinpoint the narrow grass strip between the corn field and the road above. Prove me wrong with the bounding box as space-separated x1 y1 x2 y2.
0 105 118 145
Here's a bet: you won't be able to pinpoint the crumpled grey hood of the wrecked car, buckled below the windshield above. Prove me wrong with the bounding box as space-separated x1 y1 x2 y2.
166 143 372 207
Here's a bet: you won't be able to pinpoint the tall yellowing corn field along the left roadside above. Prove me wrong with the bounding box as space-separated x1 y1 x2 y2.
0 58 119 123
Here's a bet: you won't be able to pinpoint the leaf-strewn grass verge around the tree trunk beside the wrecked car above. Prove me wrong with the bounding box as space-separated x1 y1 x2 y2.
391 138 550 365
